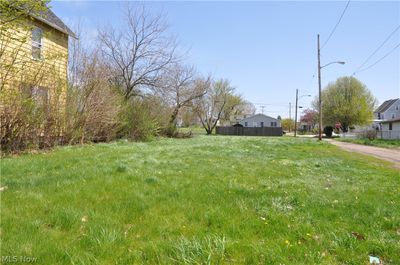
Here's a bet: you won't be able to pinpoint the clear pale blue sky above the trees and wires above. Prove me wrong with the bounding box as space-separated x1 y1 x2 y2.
51 0 400 117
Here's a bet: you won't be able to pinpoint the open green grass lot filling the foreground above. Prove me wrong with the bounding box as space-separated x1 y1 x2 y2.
1 136 400 264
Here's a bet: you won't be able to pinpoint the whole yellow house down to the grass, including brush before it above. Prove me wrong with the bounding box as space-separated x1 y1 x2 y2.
0 5 75 146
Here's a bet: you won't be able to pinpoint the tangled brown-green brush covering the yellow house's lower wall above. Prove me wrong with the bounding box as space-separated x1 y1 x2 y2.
0 84 64 153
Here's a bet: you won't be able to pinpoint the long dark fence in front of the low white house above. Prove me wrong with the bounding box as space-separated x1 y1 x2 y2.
216 126 283 136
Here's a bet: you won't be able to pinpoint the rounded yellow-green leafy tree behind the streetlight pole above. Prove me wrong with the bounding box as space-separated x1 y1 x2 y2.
314 76 376 131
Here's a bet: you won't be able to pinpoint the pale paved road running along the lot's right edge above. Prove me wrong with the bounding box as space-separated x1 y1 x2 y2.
327 139 400 168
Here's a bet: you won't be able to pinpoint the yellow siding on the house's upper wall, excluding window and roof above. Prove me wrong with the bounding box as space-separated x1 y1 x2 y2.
0 16 68 105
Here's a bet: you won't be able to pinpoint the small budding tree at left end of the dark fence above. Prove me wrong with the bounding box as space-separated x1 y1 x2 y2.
194 80 241 134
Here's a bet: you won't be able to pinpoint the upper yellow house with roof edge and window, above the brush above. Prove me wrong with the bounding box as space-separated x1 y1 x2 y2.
0 6 76 104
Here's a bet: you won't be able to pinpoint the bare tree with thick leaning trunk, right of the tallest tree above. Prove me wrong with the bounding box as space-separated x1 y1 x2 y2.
158 64 210 136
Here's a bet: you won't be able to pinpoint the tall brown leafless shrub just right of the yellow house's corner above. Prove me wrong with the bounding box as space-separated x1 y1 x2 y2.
66 47 123 143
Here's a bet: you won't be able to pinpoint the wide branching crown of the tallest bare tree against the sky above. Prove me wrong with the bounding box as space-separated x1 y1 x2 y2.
99 6 177 99
